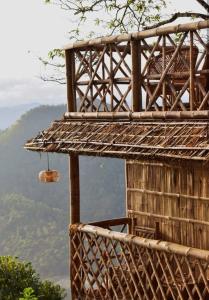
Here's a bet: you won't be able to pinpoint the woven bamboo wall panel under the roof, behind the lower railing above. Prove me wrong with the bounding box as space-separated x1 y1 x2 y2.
126 161 209 250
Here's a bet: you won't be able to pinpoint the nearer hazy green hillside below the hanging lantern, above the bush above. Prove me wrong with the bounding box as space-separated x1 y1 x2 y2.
0 194 67 277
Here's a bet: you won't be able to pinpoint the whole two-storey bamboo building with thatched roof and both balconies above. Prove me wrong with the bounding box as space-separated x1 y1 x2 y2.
25 21 209 300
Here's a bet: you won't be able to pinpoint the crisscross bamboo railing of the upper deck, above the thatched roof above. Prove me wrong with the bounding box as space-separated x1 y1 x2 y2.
65 21 209 112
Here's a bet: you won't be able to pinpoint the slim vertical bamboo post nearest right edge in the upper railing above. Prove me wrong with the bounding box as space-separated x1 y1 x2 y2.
189 31 195 110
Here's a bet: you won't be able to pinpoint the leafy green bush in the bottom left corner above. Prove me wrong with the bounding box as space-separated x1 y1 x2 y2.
0 256 66 300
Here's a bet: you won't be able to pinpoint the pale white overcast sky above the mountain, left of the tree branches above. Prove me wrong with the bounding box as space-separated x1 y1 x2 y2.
0 0 206 107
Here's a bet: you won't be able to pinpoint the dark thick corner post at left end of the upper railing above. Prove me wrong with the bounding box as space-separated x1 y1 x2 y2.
65 50 76 112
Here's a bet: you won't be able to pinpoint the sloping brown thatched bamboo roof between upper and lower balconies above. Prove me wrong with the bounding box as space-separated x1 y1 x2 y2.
25 117 209 161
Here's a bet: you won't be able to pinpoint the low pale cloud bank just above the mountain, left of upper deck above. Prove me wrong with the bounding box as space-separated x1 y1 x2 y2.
0 78 66 107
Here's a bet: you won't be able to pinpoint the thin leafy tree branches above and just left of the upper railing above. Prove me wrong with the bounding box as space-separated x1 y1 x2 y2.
40 0 209 84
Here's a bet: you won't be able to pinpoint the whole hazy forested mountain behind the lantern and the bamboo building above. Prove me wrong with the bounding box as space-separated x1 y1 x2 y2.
0 105 125 277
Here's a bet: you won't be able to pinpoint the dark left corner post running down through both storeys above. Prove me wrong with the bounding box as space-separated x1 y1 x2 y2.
65 50 80 299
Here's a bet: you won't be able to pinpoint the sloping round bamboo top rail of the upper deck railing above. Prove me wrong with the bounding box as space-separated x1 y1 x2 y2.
63 20 209 50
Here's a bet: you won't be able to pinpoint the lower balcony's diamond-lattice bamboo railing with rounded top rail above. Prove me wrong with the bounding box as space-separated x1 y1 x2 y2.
70 218 209 300
